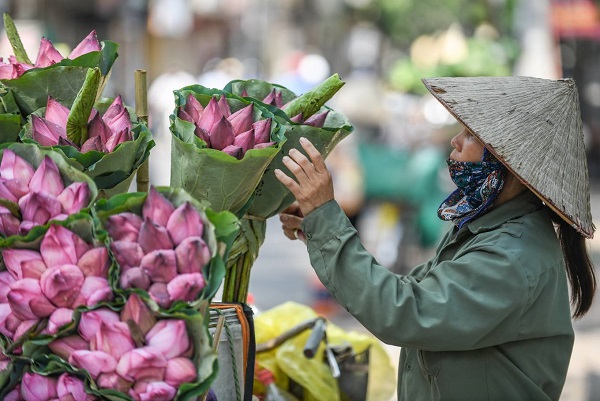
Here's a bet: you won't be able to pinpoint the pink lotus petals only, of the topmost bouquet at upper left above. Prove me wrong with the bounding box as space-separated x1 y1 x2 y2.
0 30 101 79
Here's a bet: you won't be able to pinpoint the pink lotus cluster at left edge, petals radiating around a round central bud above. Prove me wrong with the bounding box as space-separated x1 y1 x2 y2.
0 225 113 342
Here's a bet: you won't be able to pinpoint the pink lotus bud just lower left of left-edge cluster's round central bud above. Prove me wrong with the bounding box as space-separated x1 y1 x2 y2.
6 278 56 320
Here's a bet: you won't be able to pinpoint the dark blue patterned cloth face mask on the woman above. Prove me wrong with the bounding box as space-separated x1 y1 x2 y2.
438 148 506 228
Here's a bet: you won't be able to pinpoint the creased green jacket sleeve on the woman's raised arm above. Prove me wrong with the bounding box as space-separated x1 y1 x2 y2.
302 201 529 351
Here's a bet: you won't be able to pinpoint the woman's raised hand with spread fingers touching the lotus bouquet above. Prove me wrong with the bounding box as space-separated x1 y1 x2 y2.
275 138 333 219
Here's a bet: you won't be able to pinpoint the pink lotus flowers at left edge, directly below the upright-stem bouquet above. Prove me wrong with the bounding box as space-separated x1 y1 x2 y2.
0 144 96 237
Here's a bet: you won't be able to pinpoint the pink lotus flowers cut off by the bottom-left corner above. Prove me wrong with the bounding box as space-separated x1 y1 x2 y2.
4 372 98 401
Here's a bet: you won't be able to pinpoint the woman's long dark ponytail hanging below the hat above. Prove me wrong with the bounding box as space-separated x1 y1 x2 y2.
552 213 596 318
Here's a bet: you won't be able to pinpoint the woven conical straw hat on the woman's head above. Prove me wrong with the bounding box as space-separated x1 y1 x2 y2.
423 77 595 238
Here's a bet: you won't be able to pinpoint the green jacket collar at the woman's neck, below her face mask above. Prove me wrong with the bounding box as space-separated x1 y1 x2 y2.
467 190 543 234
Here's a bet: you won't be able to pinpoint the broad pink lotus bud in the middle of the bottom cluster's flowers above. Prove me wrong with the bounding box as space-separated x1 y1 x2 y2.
116 344 168 382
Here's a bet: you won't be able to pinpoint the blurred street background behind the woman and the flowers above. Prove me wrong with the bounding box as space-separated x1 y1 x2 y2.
0 0 600 401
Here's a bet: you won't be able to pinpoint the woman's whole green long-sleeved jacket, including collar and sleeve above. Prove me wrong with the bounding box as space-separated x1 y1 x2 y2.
302 191 574 401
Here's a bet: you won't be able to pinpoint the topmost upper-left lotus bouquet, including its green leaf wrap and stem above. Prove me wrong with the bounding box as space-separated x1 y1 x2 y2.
0 14 118 116
